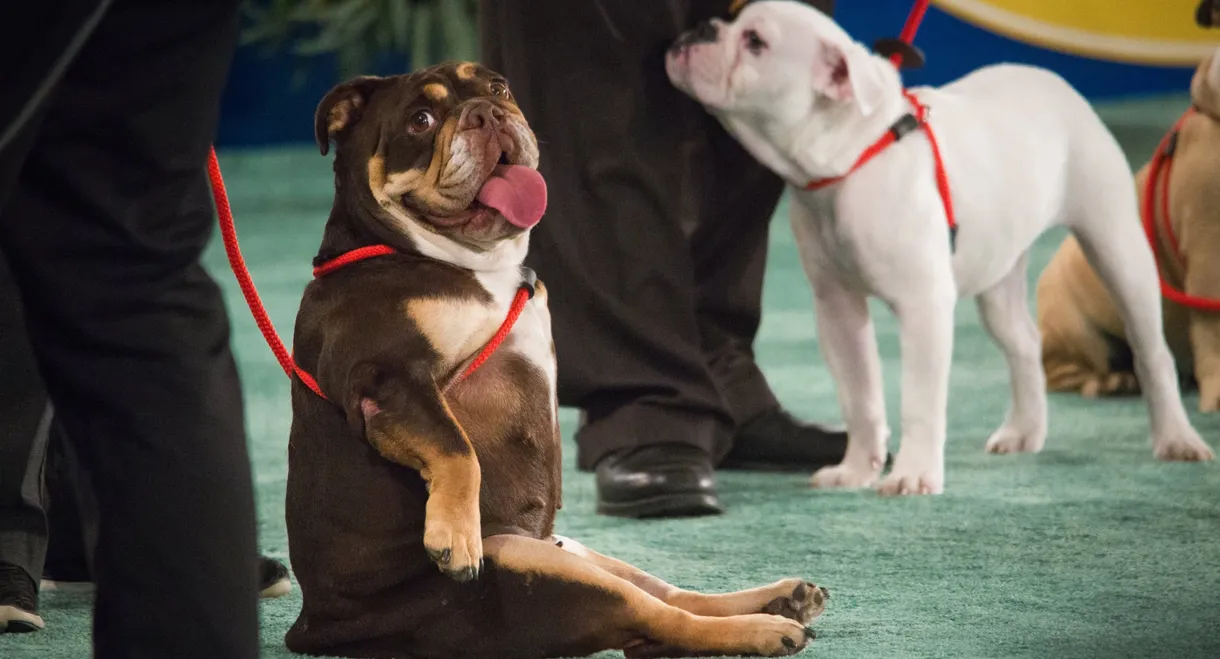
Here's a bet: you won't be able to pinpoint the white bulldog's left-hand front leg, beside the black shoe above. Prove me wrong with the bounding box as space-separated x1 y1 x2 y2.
810 275 889 488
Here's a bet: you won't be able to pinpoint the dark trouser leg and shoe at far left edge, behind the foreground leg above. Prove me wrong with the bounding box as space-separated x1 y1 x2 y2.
0 246 51 633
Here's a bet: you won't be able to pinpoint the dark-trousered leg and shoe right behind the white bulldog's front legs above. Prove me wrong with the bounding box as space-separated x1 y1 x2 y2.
689 0 847 471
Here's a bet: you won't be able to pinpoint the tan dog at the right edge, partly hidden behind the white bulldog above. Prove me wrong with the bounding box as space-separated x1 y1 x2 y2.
1037 50 1220 411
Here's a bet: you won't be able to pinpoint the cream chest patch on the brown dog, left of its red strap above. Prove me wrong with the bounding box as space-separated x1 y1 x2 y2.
406 298 503 366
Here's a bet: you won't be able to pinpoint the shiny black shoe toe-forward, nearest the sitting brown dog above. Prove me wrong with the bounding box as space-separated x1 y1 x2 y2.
595 444 725 519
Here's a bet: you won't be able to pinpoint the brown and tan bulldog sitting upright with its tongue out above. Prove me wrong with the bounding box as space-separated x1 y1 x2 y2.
285 63 827 659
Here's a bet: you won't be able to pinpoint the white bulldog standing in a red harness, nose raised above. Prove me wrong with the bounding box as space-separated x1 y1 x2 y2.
666 1 1213 494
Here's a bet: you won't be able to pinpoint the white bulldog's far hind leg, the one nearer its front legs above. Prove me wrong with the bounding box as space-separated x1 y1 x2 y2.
978 255 1047 453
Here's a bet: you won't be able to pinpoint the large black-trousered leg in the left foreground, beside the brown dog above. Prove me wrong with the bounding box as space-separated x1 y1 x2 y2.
0 0 259 658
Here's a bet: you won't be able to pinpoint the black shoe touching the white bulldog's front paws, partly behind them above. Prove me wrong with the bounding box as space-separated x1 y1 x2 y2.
720 408 888 471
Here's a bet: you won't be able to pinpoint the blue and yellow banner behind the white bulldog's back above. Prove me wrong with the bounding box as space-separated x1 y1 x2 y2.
834 0 1220 100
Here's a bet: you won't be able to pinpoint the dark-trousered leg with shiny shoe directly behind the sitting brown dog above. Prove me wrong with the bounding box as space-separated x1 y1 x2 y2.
481 0 732 516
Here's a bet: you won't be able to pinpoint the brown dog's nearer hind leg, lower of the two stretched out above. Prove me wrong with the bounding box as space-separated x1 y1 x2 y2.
470 536 813 659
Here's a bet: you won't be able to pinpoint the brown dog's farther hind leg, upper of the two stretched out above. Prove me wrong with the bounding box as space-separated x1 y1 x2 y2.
556 537 830 624
